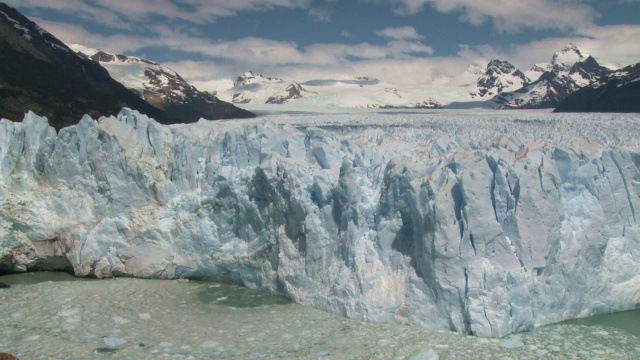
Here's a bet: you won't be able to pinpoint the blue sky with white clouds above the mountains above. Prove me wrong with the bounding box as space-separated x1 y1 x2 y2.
5 0 640 90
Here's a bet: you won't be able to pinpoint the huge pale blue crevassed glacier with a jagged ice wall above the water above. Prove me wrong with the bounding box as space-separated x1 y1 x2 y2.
0 109 640 337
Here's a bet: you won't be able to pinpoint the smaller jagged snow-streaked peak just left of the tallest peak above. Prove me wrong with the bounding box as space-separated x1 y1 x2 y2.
467 60 531 100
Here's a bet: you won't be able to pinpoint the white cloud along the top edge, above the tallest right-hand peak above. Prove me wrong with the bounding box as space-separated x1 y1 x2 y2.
394 0 597 32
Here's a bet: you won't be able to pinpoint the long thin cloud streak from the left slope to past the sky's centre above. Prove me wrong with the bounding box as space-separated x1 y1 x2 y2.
37 19 433 66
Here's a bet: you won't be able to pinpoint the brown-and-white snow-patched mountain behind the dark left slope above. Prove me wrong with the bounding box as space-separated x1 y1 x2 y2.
69 44 251 120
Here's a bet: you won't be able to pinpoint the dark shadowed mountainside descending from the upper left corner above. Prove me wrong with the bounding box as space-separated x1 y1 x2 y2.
0 3 255 129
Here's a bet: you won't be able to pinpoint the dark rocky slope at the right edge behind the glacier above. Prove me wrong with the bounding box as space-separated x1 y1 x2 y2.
555 63 640 112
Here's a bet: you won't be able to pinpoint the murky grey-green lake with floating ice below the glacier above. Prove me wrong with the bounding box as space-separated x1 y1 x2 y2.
0 272 640 360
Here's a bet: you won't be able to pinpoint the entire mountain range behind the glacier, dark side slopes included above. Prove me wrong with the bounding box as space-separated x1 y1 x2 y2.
0 3 640 120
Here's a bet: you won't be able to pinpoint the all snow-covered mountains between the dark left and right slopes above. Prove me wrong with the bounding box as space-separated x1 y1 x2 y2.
66 40 624 109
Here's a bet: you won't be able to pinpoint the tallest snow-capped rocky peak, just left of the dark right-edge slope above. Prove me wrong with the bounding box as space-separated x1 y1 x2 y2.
493 44 611 109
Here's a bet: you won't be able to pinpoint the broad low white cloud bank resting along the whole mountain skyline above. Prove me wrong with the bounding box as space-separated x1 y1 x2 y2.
36 10 640 90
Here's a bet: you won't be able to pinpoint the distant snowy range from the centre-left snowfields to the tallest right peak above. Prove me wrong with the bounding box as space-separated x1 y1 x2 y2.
212 44 632 109
